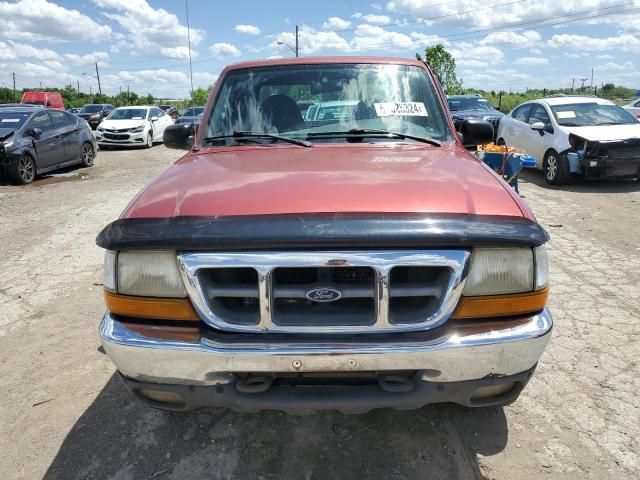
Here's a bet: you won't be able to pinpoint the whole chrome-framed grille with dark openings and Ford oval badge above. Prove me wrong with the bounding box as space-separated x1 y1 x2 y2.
178 250 470 333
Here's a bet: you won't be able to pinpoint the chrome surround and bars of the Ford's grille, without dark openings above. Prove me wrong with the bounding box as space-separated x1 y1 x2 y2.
178 250 471 333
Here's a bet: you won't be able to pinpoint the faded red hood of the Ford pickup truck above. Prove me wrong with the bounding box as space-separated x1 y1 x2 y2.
122 144 532 218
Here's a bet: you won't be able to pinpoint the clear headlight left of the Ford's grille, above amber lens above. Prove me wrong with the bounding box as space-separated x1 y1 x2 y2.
103 251 187 298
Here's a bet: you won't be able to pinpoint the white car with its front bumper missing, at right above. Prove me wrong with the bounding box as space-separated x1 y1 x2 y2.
496 95 640 184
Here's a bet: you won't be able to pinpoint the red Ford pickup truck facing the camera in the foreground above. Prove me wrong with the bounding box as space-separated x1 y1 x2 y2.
97 58 552 412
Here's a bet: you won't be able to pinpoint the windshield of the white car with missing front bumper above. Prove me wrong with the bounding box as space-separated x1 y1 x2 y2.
551 102 638 127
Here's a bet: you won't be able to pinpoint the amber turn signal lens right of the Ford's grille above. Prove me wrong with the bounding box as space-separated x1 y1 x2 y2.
451 288 549 320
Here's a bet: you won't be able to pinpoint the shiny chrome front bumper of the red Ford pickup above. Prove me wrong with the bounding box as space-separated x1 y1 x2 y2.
100 309 553 386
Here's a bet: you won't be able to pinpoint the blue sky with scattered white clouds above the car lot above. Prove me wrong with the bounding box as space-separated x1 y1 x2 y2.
0 0 640 98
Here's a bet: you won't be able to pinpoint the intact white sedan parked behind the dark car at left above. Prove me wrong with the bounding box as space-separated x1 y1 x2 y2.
96 106 173 148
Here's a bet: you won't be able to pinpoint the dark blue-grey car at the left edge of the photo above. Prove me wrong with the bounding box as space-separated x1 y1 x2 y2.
0 107 96 185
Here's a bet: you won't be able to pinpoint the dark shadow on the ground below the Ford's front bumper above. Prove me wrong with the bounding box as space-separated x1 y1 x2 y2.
44 375 507 480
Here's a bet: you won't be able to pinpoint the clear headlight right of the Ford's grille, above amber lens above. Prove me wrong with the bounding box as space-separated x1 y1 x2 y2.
463 248 534 296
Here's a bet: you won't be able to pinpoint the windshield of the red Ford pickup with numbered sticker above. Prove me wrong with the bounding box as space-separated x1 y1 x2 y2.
205 64 453 142
